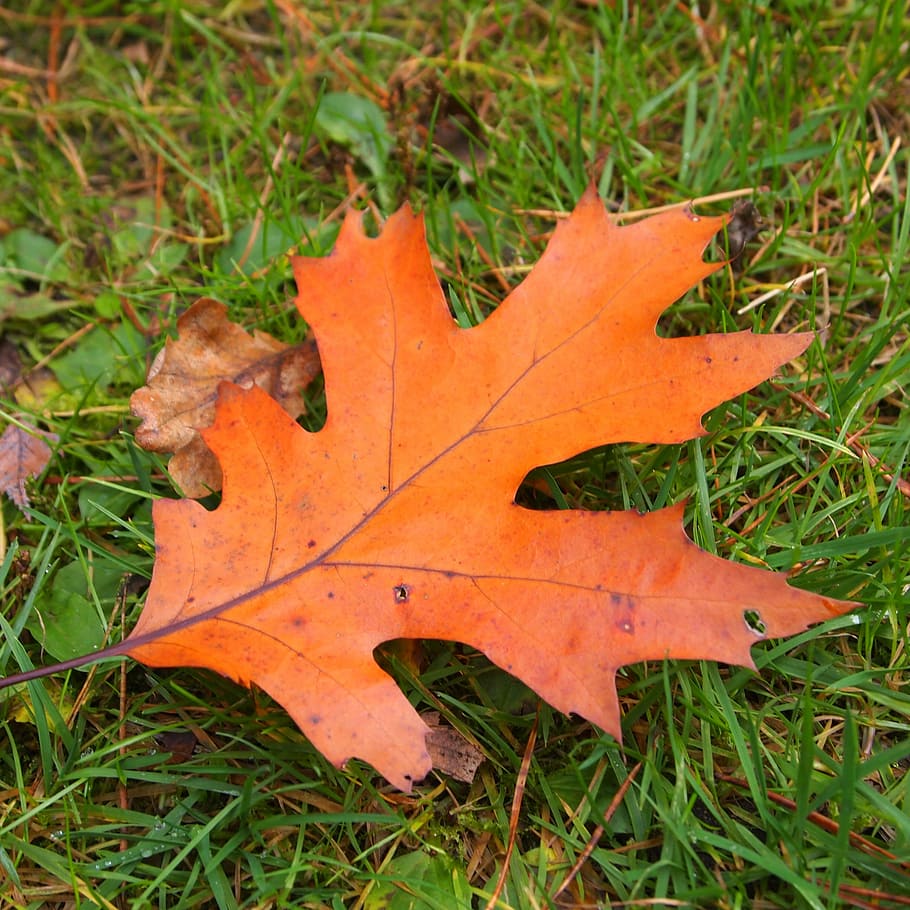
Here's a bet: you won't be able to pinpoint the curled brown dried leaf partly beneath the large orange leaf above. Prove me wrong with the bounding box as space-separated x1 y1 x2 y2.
130 297 319 498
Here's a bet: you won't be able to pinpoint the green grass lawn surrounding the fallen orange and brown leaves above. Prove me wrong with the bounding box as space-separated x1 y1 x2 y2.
0 0 910 910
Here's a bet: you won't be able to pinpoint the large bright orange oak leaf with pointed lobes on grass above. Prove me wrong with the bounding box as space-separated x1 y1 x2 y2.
0 190 853 789
